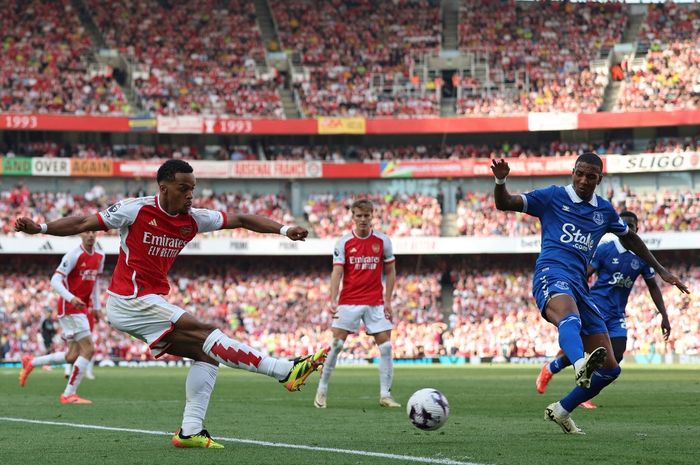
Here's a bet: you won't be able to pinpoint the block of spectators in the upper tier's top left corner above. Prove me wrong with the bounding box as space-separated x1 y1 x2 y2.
0 0 130 115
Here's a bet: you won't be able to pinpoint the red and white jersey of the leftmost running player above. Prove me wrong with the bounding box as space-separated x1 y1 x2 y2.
56 245 105 316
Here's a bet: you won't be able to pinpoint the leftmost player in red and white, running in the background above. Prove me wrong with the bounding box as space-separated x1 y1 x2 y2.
19 231 105 404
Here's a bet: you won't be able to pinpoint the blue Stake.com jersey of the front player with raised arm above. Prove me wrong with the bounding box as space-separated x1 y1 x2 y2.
521 184 628 287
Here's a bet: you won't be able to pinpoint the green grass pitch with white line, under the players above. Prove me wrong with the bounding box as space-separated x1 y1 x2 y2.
0 366 700 465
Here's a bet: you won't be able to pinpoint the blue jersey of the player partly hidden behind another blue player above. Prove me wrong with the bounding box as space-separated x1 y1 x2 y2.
591 239 656 319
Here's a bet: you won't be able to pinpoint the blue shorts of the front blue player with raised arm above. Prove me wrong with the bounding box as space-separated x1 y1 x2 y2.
532 267 608 336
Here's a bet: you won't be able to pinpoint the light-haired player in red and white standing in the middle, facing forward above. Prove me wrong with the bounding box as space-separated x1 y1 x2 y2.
314 200 401 408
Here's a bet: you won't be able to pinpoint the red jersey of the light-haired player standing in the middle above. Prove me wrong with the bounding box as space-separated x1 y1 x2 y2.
333 231 395 305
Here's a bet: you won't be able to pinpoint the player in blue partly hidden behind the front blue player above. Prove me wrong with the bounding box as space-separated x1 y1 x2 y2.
535 211 671 408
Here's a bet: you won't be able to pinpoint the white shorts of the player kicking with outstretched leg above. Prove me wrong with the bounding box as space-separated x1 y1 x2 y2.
107 294 185 358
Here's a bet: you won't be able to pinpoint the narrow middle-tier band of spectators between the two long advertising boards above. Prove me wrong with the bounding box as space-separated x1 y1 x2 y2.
0 184 700 238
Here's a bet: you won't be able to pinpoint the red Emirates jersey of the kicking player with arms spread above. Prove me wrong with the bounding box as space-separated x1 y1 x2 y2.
97 196 226 298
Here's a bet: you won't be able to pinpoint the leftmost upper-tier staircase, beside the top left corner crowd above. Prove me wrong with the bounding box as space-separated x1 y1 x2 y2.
71 0 143 112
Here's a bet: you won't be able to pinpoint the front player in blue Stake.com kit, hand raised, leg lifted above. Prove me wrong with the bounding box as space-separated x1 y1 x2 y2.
491 152 688 434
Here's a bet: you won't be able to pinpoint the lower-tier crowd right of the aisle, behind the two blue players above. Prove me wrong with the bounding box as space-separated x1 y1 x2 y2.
443 266 700 358
